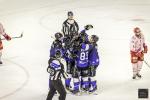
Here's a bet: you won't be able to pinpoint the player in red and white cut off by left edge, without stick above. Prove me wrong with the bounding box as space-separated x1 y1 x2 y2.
0 23 11 64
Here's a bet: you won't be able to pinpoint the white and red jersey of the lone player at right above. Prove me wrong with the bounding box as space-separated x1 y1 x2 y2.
130 34 145 52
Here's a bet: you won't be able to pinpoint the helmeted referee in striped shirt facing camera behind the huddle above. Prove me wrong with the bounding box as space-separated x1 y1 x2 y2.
62 11 79 38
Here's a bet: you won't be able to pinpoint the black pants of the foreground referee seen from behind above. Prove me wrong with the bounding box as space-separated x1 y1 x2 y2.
46 79 66 100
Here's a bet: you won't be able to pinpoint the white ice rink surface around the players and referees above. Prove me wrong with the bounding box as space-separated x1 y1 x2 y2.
0 0 150 100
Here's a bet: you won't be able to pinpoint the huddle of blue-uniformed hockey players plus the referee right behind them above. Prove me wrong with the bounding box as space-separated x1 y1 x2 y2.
50 11 99 94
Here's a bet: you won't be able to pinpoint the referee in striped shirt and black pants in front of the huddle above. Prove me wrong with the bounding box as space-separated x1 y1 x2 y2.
46 50 67 100
